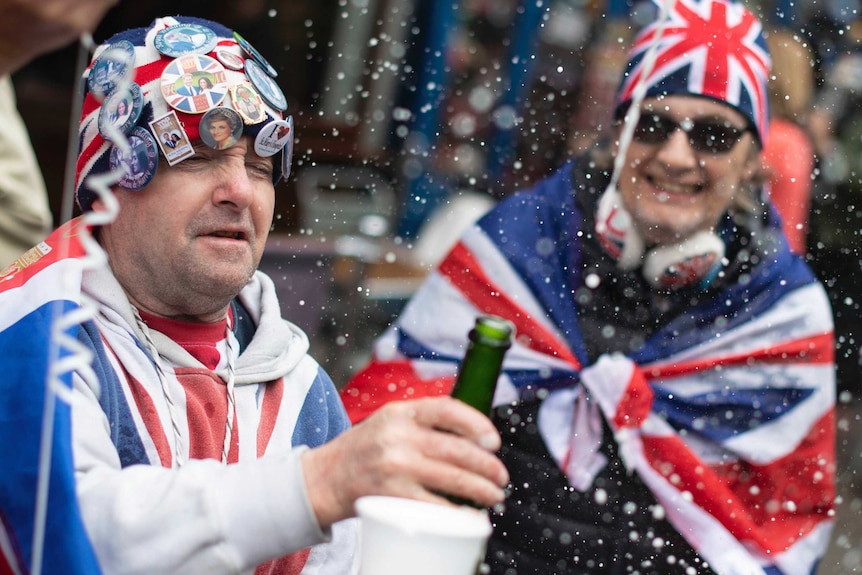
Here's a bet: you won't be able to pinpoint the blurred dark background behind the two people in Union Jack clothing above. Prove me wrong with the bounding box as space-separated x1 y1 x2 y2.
13 0 862 574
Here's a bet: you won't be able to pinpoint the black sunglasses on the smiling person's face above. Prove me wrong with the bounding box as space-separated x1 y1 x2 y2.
634 112 750 154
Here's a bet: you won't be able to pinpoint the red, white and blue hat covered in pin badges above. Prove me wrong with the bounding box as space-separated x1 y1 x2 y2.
75 16 292 211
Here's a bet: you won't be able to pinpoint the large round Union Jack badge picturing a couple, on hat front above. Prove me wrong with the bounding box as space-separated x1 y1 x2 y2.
161 54 227 114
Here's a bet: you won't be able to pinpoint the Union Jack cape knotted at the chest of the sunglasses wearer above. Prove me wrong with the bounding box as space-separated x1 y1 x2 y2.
342 164 835 575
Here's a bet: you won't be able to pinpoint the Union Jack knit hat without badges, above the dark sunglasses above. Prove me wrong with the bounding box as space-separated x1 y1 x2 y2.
615 0 771 142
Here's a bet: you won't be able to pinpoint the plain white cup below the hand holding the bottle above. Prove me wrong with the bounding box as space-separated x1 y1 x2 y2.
356 496 491 575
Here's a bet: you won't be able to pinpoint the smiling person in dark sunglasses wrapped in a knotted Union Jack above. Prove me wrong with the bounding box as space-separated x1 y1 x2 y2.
342 0 835 575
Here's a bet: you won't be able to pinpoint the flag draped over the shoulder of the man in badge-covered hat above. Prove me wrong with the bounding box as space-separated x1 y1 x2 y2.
0 219 100 575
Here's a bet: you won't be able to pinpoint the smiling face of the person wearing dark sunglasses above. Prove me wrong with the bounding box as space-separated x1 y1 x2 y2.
618 95 760 252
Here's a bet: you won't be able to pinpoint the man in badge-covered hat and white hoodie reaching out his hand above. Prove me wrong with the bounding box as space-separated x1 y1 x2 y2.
0 13 507 575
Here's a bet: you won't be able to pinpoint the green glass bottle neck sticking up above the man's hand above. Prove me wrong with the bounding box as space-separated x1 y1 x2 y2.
452 315 515 415
